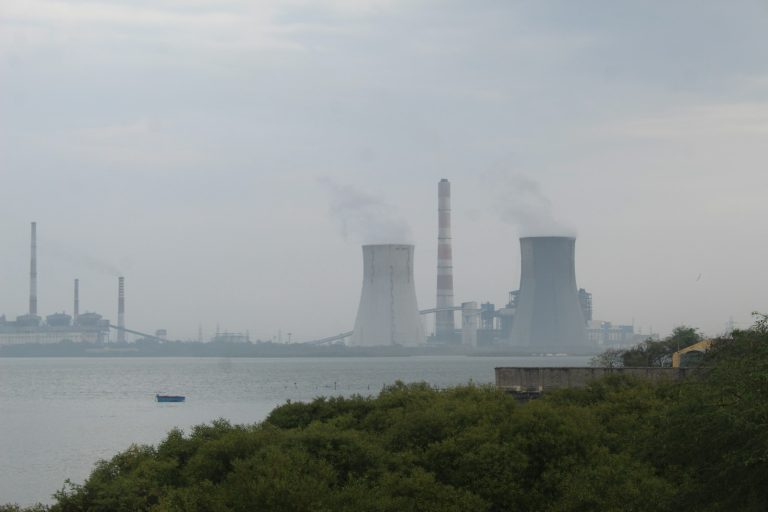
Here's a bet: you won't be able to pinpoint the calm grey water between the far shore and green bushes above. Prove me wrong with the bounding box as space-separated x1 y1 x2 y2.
0 356 589 504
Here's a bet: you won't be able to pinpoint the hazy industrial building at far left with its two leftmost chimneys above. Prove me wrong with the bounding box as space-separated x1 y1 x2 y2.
0 222 112 345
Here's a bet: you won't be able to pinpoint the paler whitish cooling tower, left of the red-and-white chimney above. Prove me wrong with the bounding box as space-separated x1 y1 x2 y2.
350 244 425 347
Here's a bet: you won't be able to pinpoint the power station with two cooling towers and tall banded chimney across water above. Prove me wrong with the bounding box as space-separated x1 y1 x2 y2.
342 179 624 354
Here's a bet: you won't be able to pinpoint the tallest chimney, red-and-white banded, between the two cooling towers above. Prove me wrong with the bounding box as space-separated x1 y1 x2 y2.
435 178 454 340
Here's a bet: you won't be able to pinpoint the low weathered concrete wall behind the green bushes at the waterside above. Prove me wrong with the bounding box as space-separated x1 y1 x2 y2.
496 367 694 391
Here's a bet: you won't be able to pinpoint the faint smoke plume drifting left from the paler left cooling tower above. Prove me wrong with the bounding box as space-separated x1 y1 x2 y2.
318 177 413 244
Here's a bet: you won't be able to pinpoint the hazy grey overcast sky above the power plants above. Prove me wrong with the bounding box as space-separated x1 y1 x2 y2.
0 0 768 340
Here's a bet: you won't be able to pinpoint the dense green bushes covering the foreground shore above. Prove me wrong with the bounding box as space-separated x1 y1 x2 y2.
7 317 768 512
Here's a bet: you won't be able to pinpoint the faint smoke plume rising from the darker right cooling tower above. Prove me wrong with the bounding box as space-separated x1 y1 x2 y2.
491 174 576 237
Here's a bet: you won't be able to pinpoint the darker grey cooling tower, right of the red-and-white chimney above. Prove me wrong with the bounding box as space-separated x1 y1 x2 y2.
511 236 590 353
